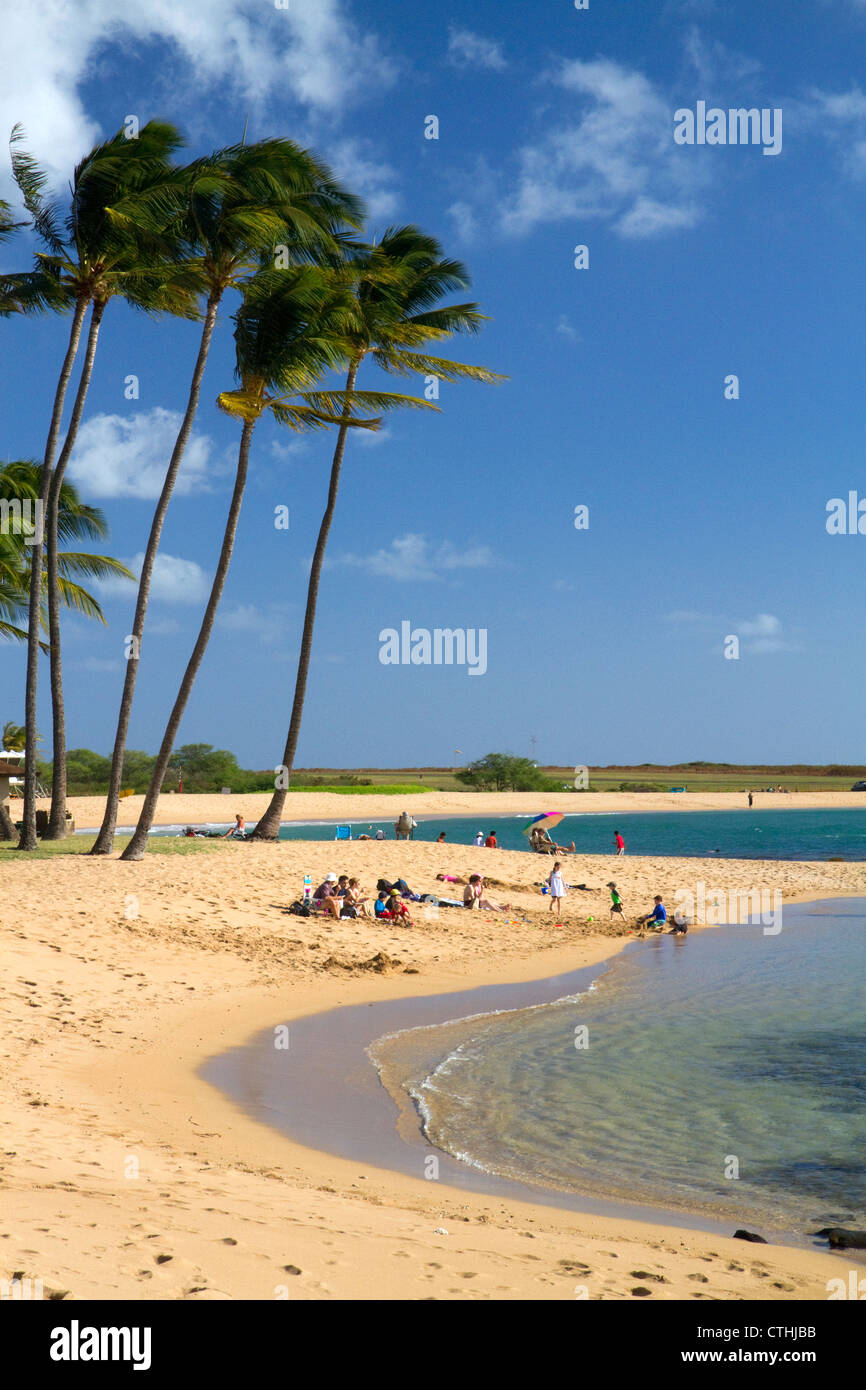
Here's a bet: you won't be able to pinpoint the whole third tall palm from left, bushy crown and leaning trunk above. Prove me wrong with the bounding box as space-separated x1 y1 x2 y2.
90 140 361 855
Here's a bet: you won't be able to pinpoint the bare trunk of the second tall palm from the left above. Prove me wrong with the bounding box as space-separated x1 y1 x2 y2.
43 299 107 840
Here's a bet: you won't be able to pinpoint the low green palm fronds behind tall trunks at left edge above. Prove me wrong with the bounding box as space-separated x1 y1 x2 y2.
0 459 135 642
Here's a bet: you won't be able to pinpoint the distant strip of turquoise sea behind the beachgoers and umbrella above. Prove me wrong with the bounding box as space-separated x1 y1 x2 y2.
130 794 866 860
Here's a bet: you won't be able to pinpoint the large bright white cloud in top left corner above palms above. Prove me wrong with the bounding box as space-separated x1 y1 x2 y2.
0 0 396 198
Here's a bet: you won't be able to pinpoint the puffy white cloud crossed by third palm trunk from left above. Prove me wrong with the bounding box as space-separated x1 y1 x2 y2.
70 406 211 498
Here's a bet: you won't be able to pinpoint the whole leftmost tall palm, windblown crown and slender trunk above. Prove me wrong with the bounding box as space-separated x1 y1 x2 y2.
3 121 195 849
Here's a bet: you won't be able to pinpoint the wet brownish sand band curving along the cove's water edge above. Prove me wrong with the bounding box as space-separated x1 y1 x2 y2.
197 898 866 1259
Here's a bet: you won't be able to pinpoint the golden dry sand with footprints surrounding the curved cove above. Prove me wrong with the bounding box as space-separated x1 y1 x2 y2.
0 796 866 1300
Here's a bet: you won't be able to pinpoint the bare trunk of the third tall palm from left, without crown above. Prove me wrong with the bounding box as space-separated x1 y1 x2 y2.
90 291 222 855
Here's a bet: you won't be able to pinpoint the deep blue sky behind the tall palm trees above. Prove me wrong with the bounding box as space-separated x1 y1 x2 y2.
0 0 866 767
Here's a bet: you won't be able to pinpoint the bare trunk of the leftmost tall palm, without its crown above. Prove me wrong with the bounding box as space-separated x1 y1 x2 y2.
18 296 88 849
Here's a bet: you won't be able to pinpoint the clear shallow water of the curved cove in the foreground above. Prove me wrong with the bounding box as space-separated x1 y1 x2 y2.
371 899 866 1236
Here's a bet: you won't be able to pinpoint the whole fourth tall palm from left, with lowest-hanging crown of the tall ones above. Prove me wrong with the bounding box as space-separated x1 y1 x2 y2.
121 265 400 860
